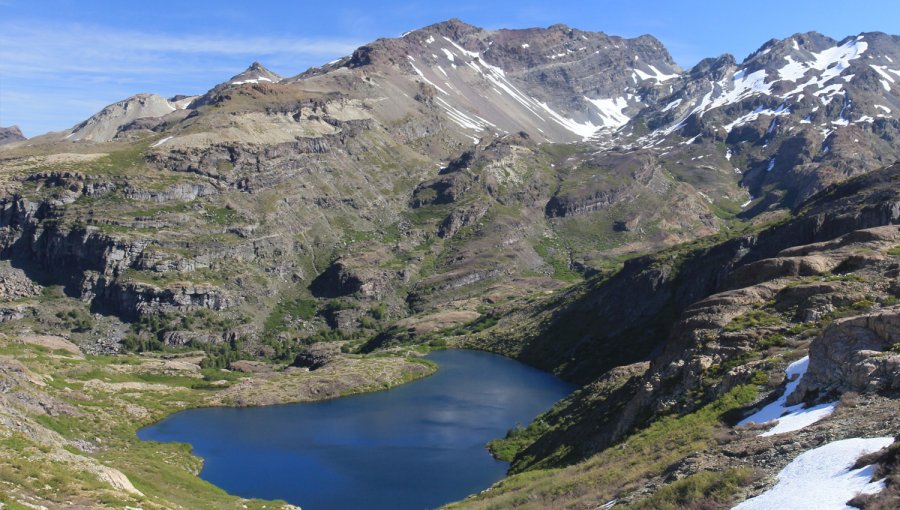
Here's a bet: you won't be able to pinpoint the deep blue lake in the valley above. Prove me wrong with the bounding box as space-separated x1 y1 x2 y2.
138 350 574 510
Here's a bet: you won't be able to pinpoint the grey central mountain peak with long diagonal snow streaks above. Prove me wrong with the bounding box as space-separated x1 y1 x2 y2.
316 19 681 141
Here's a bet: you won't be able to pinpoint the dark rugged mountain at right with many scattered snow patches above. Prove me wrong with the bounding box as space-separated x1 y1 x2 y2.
608 32 900 211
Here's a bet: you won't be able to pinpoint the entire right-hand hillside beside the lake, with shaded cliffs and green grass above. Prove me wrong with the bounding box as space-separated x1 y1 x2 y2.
450 165 900 508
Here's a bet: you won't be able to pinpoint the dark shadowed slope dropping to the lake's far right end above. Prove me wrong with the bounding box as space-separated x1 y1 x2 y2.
472 165 900 382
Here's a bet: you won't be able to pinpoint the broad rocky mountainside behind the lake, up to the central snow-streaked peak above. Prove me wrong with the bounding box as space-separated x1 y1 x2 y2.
3 20 744 356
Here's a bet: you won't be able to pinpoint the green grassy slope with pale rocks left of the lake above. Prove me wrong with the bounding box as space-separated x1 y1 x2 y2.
0 341 434 509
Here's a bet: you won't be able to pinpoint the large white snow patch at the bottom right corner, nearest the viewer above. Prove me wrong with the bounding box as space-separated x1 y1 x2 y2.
732 437 894 510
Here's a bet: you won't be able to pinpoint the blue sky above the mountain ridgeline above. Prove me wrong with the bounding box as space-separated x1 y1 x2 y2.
0 0 900 136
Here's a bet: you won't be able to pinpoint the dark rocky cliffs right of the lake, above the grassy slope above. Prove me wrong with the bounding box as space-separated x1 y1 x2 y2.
468 165 900 471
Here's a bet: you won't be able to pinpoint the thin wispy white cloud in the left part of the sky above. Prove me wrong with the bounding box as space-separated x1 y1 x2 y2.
0 21 359 136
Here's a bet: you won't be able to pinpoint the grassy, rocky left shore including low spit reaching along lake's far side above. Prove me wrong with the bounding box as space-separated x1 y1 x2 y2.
0 338 446 510
